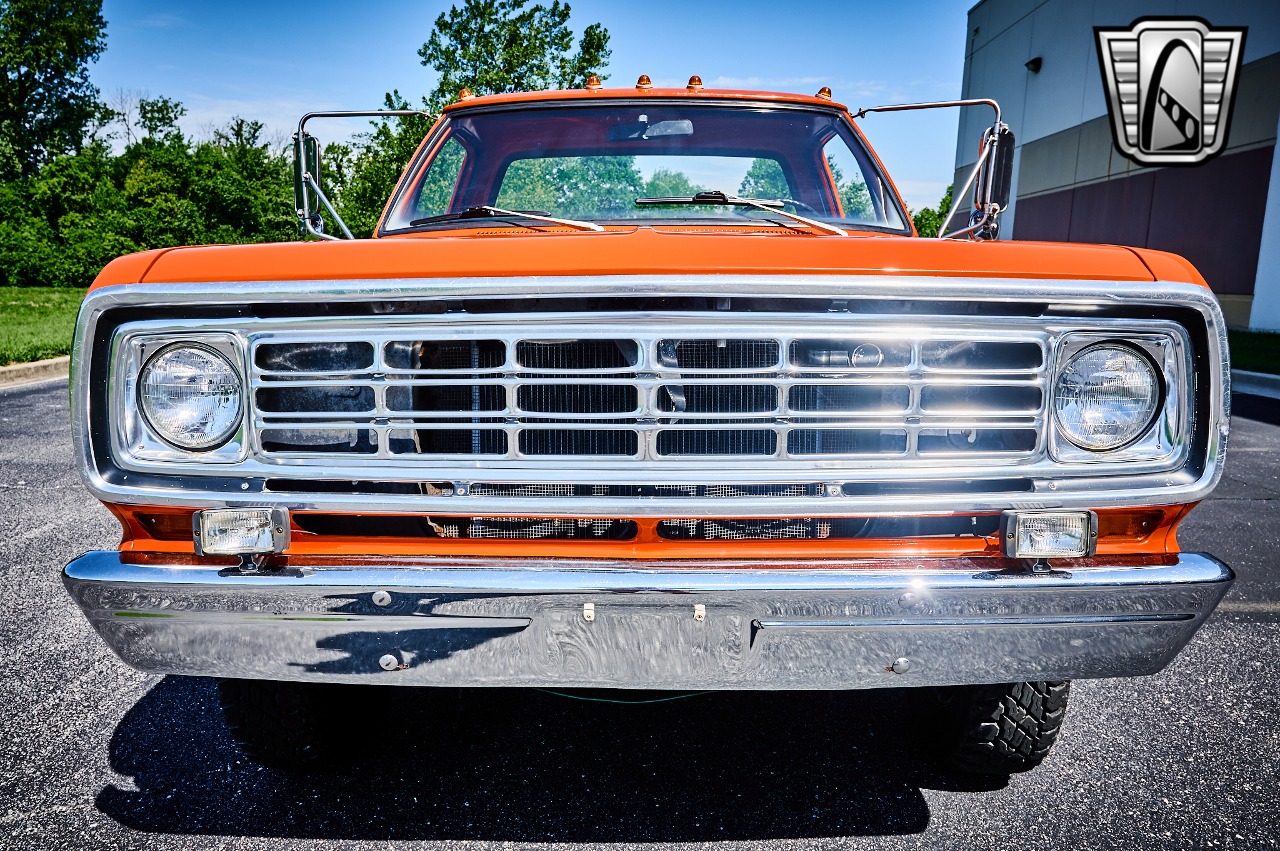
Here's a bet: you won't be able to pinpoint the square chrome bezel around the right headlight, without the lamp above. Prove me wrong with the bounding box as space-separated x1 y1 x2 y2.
1046 331 1194 463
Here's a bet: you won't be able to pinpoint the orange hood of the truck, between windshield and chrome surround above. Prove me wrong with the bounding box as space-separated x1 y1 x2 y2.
93 228 1203 288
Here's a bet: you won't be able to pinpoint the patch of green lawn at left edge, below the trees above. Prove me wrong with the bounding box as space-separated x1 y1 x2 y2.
0 287 84 366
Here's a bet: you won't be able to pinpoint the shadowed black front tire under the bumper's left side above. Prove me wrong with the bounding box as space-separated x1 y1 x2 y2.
218 680 368 772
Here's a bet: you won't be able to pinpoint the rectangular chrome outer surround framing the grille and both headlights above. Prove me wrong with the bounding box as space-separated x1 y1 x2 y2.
72 275 1230 517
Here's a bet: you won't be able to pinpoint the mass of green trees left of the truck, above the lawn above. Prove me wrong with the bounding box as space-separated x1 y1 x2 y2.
0 0 298 287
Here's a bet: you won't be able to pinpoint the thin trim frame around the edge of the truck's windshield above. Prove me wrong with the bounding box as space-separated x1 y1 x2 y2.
374 95 914 237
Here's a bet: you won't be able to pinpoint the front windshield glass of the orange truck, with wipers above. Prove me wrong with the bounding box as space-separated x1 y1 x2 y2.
384 101 908 232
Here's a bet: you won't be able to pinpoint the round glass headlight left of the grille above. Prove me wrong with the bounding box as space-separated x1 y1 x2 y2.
138 343 241 449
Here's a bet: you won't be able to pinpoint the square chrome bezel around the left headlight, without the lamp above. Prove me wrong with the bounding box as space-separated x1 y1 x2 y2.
110 333 251 465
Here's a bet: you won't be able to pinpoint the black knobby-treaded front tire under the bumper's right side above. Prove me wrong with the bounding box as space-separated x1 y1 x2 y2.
941 681 1071 774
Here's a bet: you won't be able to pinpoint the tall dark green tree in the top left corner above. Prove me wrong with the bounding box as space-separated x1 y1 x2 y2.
0 0 106 178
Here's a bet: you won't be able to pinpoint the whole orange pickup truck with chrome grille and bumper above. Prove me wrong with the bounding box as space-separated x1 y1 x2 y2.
64 78 1233 773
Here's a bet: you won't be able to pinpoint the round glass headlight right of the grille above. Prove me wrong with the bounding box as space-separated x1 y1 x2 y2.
1053 343 1160 452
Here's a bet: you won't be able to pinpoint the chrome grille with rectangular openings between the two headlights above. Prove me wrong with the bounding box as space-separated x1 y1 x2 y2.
250 316 1050 467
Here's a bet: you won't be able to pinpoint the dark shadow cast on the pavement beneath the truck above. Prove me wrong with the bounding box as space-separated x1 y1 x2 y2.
96 677 1002 843
